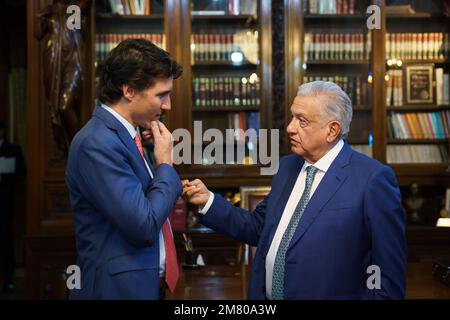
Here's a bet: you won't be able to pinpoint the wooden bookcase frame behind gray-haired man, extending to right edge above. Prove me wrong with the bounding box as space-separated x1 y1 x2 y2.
285 0 450 222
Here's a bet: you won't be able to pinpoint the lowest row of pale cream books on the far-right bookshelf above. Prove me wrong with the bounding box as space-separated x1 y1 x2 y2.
386 144 449 163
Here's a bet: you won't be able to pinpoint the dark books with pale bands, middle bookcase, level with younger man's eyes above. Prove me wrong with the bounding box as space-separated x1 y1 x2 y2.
192 74 260 107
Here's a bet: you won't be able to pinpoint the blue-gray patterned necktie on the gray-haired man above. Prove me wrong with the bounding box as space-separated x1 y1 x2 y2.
272 166 318 300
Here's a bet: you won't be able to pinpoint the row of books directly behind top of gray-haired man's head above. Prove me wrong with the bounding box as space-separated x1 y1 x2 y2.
303 75 368 105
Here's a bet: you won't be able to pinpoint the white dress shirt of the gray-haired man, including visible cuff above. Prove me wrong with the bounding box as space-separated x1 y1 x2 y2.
199 140 344 300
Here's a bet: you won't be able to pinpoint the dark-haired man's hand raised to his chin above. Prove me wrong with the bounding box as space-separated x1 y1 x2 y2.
150 121 173 166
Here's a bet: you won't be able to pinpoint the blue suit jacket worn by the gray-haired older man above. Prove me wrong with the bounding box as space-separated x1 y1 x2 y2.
200 144 406 299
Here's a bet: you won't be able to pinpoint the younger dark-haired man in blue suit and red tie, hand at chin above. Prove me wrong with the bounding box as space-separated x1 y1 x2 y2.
66 39 182 299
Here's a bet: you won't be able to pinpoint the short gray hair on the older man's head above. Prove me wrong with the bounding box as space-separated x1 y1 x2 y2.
297 81 353 139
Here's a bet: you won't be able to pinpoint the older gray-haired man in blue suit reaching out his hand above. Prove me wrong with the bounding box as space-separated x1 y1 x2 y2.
183 81 406 299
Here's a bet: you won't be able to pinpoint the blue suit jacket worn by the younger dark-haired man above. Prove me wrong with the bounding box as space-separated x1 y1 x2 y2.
66 107 182 299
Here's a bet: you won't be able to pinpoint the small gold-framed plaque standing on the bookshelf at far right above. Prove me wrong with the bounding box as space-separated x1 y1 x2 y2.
405 64 434 104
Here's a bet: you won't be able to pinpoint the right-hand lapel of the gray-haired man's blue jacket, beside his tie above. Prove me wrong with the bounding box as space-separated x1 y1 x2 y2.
289 144 352 247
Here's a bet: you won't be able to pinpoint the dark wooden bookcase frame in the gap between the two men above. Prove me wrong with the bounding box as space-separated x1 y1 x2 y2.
173 0 272 184
